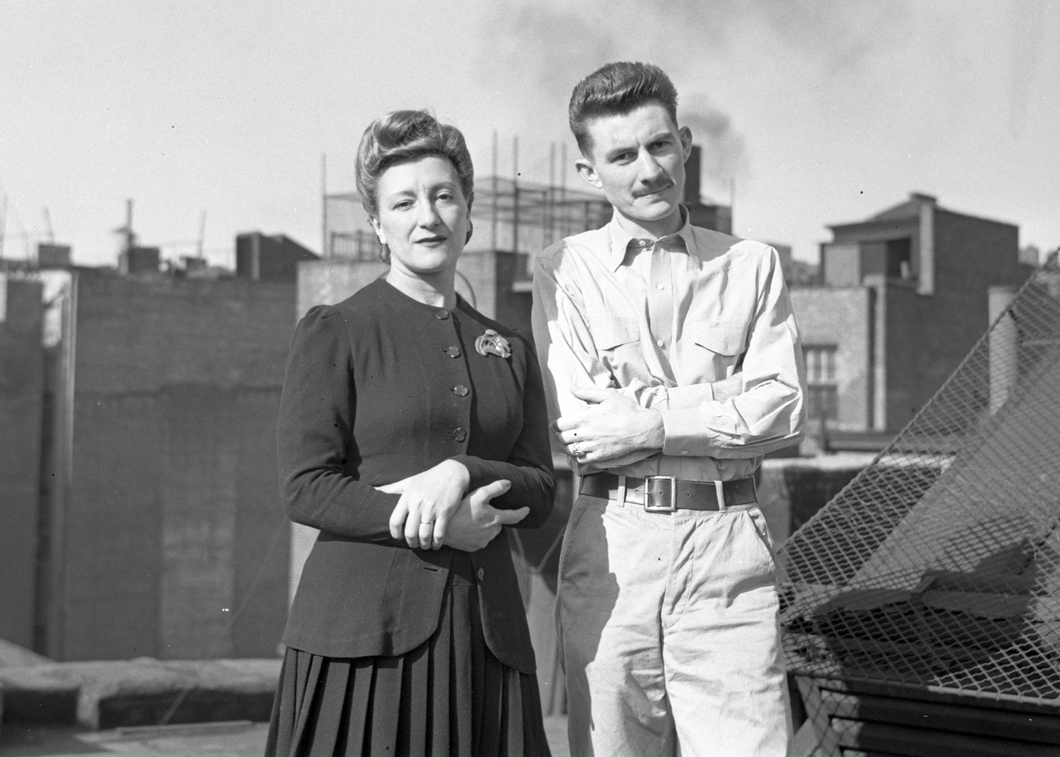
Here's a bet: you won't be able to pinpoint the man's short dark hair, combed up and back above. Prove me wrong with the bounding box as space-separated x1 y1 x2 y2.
567 61 677 157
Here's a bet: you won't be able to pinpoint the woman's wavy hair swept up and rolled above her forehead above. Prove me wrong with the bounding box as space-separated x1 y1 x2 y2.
356 110 475 217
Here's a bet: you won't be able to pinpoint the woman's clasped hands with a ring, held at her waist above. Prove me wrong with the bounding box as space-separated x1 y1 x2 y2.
378 460 530 552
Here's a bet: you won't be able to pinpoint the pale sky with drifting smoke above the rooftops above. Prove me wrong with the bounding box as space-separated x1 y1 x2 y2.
0 0 1060 265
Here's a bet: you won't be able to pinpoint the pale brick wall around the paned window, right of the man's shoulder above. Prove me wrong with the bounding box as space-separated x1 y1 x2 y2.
791 286 873 430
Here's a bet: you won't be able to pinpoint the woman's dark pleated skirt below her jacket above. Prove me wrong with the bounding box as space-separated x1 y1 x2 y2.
265 558 549 757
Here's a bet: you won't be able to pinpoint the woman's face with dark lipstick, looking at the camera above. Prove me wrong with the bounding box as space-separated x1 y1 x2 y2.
372 155 469 278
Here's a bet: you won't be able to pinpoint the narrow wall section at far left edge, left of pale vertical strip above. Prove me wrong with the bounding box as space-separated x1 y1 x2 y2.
0 274 45 648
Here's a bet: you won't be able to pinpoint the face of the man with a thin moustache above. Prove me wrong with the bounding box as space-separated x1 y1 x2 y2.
578 102 692 233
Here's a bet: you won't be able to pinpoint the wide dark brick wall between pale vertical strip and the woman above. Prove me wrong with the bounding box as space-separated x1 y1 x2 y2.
43 274 295 659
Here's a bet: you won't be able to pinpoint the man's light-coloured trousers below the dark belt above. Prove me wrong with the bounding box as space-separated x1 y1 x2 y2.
558 495 792 757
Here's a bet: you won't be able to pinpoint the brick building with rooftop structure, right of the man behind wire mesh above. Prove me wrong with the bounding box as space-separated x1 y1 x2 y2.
791 193 1030 444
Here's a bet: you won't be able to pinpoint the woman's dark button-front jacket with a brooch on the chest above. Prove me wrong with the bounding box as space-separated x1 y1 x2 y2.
278 280 554 673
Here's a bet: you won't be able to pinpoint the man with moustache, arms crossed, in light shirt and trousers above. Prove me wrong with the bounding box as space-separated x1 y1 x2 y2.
533 63 803 757
